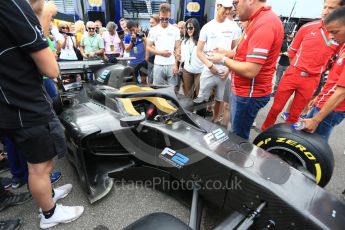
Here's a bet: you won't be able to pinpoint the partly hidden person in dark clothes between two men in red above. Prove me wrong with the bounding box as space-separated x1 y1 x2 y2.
274 33 293 92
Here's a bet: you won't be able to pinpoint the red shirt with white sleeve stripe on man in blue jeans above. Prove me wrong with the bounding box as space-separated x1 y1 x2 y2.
232 7 284 97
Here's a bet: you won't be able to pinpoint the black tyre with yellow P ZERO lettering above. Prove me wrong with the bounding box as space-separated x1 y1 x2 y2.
254 124 334 187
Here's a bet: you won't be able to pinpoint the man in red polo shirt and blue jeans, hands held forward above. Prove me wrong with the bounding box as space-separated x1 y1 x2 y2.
210 0 284 139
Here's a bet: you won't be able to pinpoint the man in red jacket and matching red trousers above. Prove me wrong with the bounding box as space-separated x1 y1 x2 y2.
261 0 345 130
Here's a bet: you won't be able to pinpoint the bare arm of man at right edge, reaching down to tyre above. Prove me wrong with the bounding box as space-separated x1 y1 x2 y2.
303 86 345 133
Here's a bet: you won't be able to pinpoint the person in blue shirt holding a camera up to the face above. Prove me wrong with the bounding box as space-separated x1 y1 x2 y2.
123 21 147 84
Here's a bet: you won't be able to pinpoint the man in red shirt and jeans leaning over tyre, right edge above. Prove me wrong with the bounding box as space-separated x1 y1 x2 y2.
304 7 345 141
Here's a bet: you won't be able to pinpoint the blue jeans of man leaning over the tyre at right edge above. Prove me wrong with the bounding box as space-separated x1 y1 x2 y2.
307 106 345 142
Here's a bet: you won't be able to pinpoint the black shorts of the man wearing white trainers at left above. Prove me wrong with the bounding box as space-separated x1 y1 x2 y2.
2 117 67 164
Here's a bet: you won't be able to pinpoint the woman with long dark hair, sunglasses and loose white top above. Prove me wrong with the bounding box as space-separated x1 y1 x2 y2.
181 18 204 98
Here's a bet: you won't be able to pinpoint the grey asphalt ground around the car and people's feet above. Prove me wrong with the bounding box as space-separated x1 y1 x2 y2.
0 99 345 230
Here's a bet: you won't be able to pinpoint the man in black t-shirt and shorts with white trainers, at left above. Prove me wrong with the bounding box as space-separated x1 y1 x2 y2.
0 0 84 229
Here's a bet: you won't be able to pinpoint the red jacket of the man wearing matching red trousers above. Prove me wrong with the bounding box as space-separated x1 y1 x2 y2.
289 20 339 74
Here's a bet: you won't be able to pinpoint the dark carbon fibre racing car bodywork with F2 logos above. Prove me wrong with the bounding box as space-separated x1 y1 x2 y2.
60 84 345 229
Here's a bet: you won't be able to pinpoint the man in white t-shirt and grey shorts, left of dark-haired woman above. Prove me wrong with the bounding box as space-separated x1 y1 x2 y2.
147 3 180 86
